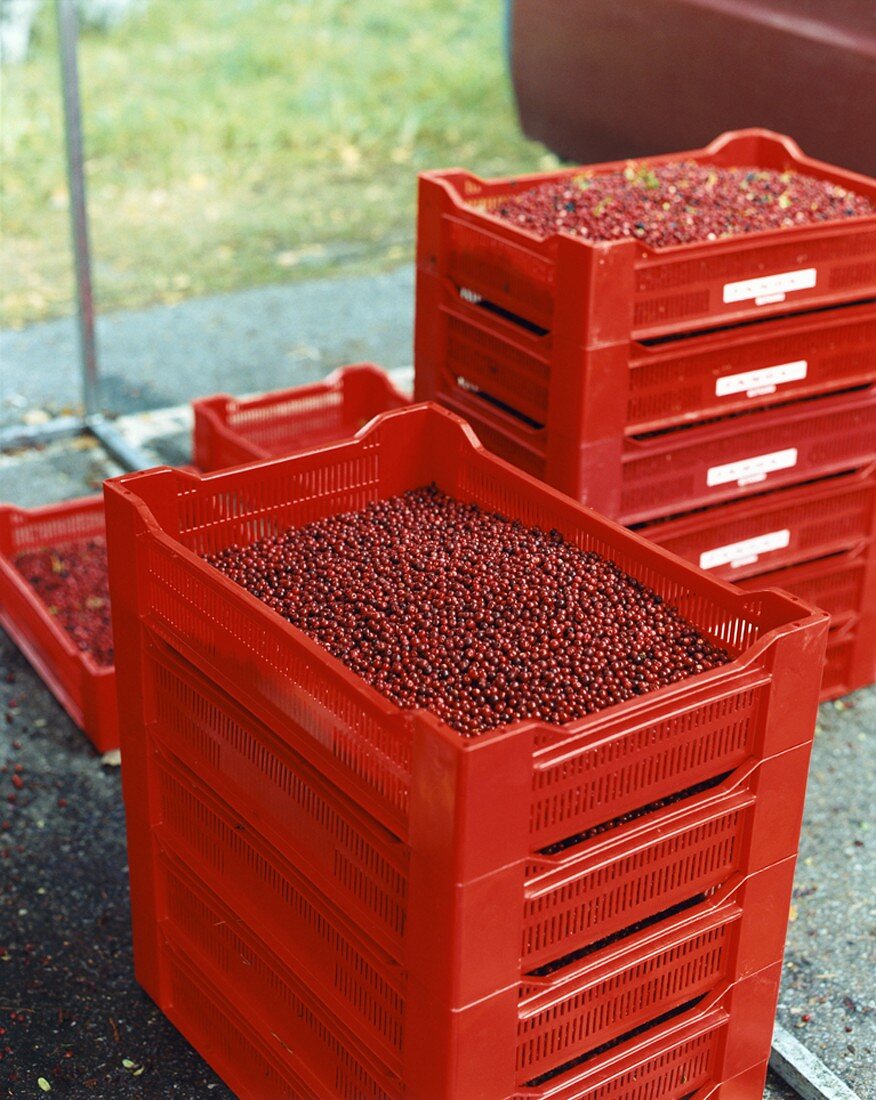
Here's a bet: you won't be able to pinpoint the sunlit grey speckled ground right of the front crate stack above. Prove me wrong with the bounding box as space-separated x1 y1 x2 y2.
778 688 876 1100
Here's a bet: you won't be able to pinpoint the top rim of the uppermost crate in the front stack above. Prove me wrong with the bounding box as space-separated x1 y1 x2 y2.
103 402 830 751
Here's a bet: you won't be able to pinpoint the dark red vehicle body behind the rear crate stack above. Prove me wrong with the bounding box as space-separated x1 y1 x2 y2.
508 0 876 176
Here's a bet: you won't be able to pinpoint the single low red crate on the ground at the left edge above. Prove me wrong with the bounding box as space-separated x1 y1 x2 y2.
0 496 119 752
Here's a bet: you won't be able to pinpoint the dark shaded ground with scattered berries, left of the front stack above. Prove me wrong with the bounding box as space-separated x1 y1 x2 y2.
0 631 232 1098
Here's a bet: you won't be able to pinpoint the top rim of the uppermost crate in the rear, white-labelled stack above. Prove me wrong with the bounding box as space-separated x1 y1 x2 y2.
418 127 876 262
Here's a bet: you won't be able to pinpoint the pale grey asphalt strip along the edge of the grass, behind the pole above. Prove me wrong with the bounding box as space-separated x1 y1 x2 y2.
0 265 414 429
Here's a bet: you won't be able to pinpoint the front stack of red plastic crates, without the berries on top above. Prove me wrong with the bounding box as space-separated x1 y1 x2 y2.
106 405 828 1100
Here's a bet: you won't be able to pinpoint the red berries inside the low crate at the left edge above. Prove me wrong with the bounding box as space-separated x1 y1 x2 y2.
15 538 112 664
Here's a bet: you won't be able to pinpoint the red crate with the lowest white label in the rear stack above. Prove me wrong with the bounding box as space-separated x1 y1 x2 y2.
637 465 876 582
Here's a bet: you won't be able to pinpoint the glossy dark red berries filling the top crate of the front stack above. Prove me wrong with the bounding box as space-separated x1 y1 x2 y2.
207 485 730 736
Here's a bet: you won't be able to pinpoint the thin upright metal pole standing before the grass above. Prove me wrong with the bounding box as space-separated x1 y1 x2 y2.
55 0 98 417
